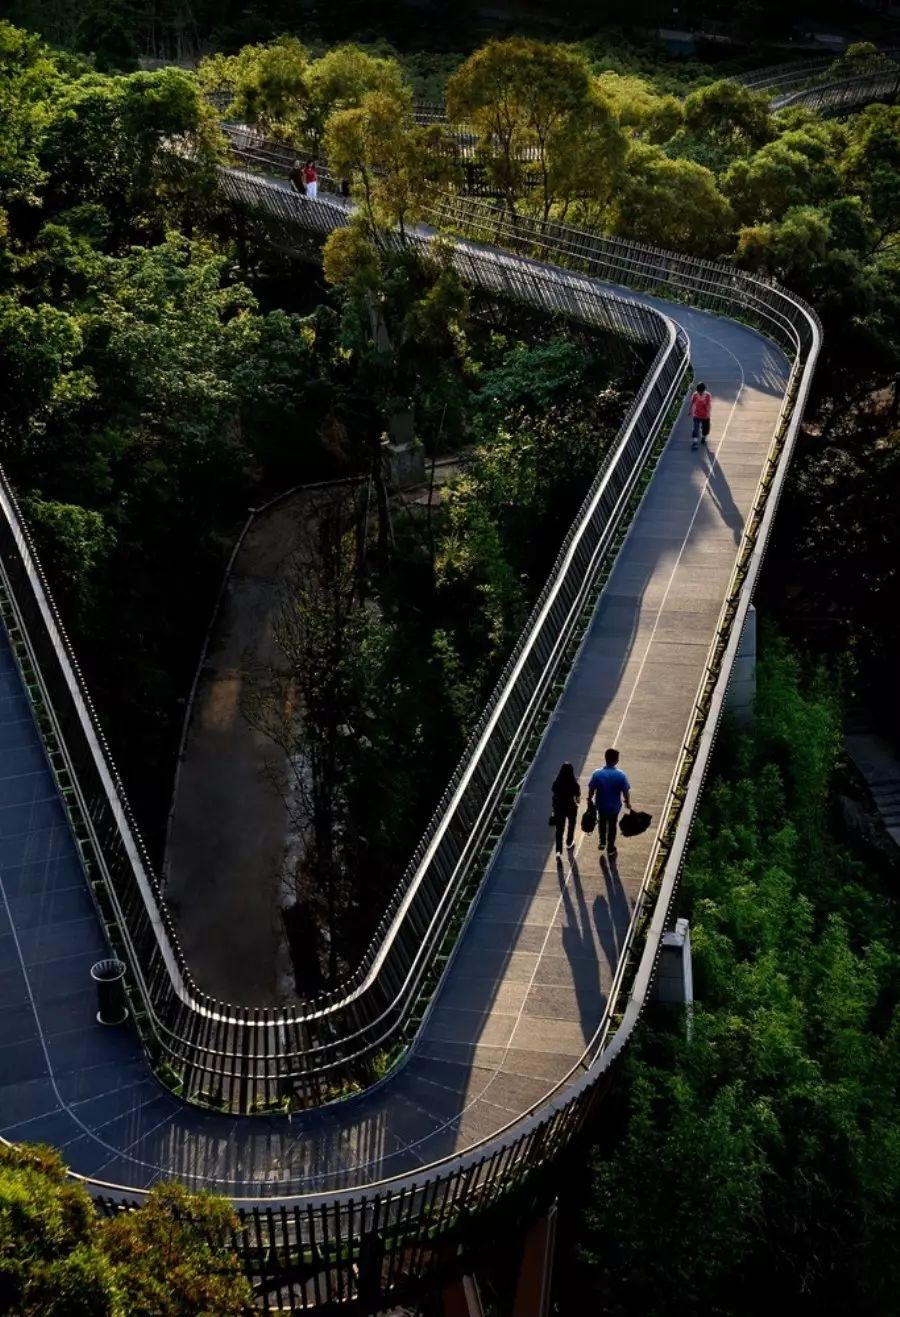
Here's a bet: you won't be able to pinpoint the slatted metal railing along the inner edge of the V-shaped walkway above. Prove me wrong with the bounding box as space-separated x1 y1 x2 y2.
0 173 687 1112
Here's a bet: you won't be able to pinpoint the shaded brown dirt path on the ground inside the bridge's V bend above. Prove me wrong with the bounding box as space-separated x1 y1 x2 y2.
163 490 332 1006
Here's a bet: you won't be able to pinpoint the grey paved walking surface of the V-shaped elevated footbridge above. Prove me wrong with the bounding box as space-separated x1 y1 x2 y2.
0 229 788 1198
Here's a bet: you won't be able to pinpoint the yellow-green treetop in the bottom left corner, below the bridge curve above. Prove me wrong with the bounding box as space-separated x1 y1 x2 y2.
0 1144 252 1317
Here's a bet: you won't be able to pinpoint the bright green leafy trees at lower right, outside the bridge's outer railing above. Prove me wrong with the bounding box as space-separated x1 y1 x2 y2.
561 645 900 1317
